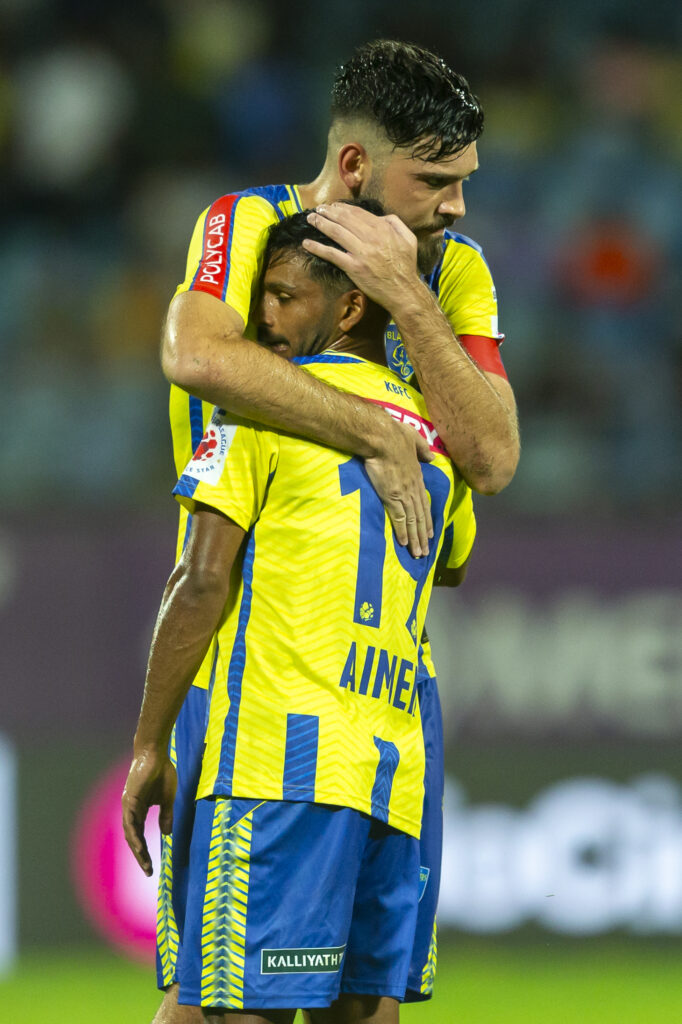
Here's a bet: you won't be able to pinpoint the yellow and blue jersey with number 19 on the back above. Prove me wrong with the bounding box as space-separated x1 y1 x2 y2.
175 352 475 836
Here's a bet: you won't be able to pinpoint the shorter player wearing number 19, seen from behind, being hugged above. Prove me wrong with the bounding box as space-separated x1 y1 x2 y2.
124 201 475 1024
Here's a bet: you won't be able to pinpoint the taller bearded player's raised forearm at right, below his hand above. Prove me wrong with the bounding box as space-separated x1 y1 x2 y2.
391 284 519 494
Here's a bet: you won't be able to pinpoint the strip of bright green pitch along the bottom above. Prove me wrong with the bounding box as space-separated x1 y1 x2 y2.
0 939 682 1024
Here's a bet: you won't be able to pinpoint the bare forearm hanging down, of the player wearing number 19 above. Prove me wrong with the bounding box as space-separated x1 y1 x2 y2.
134 568 225 752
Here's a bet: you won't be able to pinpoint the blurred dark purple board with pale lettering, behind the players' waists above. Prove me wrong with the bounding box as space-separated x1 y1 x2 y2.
0 516 682 741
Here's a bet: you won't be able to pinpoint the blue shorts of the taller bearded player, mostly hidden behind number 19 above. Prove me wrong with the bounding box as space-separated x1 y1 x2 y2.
157 674 443 1002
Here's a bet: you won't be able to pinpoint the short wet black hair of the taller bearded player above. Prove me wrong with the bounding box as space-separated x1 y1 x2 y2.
331 39 483 161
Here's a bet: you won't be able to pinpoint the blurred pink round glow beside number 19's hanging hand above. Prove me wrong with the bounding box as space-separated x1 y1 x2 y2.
72 760 159 963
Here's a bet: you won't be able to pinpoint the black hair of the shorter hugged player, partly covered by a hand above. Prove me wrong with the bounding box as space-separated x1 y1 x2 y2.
264 199 384 292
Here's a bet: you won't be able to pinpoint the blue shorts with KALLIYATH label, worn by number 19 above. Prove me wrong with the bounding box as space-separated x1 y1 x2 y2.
178 797 419 1011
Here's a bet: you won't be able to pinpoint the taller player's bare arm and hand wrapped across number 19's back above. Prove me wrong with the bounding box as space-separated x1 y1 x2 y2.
161 292 433 557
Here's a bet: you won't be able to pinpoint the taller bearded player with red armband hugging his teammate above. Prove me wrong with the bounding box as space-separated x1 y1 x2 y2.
122 41 518 1024
